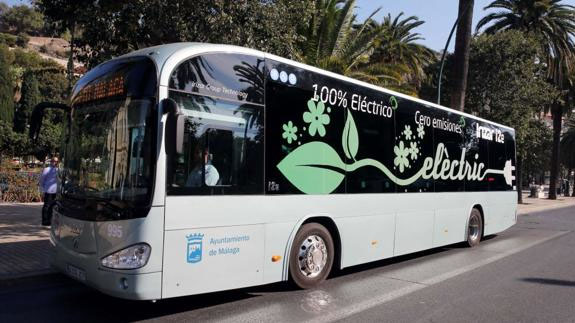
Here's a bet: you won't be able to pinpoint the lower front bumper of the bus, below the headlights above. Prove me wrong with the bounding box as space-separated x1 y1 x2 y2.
50 244 162 300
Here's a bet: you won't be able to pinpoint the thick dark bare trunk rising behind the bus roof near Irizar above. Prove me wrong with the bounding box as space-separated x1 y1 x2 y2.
451 0 474 111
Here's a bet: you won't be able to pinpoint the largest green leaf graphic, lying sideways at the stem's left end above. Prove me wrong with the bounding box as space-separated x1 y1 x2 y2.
277 141 345 194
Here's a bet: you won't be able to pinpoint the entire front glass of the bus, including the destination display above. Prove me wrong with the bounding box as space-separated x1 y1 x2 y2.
61 57 157 221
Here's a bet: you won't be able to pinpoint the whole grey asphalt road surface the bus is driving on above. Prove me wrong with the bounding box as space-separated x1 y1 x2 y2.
0 207 575 322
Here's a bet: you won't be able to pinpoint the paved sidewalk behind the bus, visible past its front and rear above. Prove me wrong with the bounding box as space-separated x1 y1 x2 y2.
0 195 575 283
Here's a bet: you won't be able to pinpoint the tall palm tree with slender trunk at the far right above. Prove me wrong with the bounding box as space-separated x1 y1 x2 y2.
477 0 575 199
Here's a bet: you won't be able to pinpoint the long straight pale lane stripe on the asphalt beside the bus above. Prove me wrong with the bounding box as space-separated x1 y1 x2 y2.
308 231 570 323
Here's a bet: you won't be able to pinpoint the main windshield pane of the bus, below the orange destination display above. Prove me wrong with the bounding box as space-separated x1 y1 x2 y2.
63 98 153 202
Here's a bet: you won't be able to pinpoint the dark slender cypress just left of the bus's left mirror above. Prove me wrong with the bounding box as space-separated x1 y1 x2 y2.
14 72 40 133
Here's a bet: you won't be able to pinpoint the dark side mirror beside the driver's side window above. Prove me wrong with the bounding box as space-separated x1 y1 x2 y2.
162 99 186 155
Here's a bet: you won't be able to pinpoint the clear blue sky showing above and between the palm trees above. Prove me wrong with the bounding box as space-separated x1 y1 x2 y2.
0 0 575 51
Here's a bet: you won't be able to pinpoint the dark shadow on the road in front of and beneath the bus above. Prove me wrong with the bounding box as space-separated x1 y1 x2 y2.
0 236 500 322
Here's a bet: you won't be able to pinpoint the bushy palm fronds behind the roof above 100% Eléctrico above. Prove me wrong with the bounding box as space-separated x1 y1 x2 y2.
296 0 430 94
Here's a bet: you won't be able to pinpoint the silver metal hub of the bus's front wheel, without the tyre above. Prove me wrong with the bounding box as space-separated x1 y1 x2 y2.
298 235 328 278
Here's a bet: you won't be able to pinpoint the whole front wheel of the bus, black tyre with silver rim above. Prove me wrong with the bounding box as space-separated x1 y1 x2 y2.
289 223 335 289
